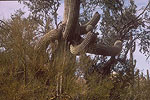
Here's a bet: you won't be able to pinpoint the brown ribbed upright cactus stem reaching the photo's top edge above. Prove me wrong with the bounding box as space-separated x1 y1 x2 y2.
63 0 80 40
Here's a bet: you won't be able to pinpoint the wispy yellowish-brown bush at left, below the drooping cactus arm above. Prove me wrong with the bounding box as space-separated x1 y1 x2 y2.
0 11 78 100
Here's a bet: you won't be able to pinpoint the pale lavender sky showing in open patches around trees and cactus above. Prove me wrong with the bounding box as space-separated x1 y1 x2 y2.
0 0 150 73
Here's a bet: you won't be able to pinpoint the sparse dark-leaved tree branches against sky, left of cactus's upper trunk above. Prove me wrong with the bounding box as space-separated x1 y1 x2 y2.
24 0 61 28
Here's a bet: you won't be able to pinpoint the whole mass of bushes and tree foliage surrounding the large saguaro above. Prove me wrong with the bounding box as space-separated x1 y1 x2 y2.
0 0 150 100
